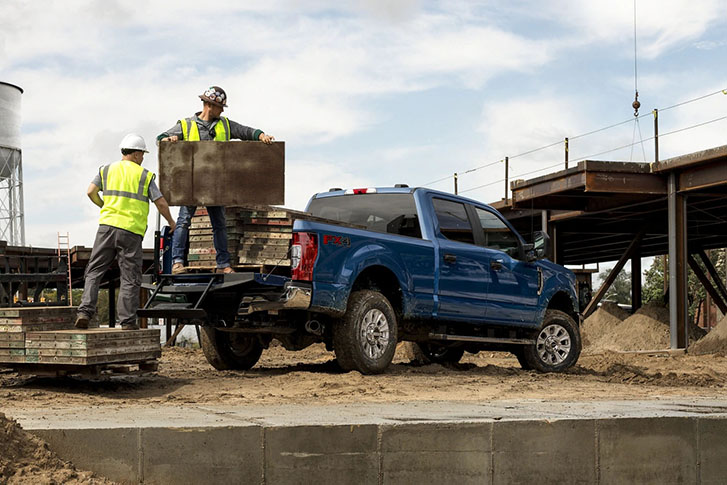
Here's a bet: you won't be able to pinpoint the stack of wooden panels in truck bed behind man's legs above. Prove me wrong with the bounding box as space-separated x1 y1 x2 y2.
187 207 296 269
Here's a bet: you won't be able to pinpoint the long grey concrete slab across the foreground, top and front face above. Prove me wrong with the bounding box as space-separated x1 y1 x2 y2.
8 399 727 484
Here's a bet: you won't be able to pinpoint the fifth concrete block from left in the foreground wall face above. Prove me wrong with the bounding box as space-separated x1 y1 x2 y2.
492 419 596 484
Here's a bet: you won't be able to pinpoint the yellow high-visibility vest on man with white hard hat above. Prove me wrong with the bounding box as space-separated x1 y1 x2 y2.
98 160 154 237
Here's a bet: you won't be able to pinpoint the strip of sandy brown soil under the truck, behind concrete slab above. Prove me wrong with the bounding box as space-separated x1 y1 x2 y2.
0 345 727 409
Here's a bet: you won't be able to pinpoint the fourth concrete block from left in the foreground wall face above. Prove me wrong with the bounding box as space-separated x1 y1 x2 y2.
381 423 492 484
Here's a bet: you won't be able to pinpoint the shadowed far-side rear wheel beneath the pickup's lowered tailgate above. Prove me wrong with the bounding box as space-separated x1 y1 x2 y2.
200 326 263 370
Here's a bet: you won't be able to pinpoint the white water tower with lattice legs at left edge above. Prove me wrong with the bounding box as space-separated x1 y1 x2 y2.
0 81 25 246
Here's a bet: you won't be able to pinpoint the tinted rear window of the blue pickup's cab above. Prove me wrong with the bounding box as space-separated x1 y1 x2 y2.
308 194 422 238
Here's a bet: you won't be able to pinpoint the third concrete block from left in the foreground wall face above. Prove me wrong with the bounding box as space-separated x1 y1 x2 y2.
265 425 379 485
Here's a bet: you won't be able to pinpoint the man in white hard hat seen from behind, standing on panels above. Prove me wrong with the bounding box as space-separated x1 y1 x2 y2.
76 133 176 330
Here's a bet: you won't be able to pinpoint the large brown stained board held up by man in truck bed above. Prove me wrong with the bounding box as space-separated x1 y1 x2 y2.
159 141 285 206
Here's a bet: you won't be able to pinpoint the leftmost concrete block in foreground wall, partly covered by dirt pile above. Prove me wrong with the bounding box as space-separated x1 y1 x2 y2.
30 428 141 484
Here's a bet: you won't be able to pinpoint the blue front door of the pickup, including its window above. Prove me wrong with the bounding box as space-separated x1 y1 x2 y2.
474 207 541 325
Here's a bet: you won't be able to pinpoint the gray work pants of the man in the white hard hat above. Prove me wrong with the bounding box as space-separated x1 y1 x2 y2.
78 225 143 325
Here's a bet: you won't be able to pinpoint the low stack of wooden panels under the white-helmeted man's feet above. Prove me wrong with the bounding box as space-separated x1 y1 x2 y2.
0 307 161 367
